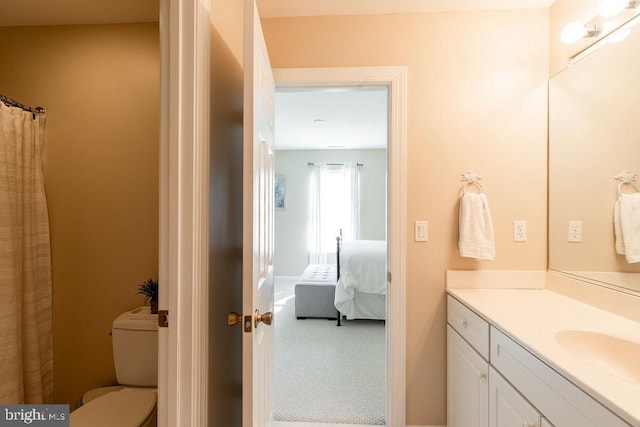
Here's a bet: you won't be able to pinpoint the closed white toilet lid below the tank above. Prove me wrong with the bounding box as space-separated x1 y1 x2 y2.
69 388 157 427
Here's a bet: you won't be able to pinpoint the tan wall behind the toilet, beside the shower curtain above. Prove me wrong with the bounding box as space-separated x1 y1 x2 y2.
0 23 159 403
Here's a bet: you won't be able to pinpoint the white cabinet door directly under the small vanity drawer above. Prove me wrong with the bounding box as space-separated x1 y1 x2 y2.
447 325 488 427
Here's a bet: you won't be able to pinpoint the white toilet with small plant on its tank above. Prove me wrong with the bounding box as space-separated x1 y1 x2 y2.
69 306 158 427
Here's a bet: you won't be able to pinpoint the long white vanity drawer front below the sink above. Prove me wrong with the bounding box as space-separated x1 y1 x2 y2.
491 327 629 427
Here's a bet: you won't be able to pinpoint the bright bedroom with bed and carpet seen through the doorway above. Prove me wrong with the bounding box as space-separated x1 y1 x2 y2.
274 85 389 427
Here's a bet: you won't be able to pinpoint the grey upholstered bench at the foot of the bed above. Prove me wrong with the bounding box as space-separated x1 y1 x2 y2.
294 282 338 319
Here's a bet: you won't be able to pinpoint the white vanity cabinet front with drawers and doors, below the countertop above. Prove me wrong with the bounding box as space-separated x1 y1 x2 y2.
447 296 630 427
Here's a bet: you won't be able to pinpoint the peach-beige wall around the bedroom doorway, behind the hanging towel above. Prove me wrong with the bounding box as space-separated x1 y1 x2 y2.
263 9 549 425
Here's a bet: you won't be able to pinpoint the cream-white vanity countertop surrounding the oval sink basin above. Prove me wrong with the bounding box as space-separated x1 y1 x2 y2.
447 289 640 427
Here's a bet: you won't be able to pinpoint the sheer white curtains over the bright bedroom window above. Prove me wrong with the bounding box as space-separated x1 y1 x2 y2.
309 165 360 264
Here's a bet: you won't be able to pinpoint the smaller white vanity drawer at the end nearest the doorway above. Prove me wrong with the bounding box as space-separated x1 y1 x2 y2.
447 296 489 360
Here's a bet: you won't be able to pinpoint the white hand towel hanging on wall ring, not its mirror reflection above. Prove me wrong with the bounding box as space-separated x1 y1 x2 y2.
458 192 496 261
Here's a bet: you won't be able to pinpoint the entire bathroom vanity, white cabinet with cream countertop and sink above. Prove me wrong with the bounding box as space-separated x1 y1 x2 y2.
447 289 640 427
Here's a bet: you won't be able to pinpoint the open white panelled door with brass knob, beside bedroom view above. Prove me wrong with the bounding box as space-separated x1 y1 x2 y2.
242 0 275 427
